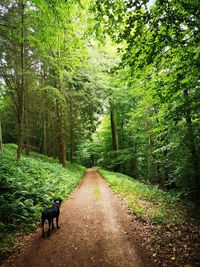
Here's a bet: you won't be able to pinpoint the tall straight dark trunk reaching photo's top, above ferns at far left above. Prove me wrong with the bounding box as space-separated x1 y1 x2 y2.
17 0 24 160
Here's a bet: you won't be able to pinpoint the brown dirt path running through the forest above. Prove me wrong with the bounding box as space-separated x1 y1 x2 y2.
3 169 155 267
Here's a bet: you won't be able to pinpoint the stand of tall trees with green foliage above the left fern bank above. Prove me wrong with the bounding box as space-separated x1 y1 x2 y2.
0 0 100 161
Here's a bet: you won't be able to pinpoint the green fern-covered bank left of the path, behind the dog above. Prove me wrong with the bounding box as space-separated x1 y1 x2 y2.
0 144 85 258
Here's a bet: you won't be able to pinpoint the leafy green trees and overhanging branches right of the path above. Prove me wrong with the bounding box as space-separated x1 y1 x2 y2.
91 0 200 197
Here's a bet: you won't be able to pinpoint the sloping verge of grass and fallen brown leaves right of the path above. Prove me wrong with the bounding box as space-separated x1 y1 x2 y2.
98 169 200 267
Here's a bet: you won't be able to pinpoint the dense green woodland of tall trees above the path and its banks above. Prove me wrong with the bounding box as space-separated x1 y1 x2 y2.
0 0 200 199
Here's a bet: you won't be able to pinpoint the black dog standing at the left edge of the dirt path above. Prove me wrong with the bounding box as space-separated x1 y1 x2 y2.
42 198 62 237
